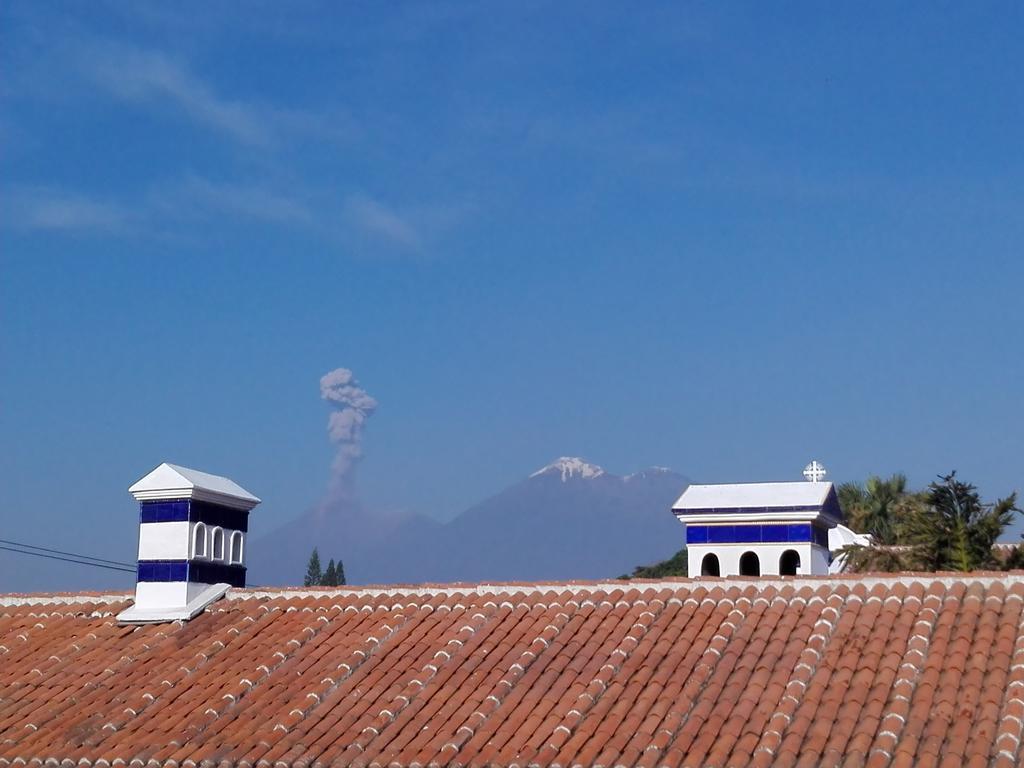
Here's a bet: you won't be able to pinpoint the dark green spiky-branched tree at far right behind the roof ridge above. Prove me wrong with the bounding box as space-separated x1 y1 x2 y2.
906 472 1021 571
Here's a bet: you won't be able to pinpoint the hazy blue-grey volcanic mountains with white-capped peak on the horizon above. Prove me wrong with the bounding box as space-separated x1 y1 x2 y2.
250 458 688 585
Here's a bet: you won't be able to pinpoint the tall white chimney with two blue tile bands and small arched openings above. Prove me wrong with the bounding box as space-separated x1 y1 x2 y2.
118 464 259 624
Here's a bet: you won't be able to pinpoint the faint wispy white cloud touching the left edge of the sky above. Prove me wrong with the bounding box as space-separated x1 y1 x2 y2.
3 187 132 232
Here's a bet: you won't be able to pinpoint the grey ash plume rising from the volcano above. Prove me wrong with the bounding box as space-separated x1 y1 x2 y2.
321 368 377 502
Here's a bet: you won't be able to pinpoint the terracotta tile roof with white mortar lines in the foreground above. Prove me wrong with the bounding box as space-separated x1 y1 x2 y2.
0 573 1024 768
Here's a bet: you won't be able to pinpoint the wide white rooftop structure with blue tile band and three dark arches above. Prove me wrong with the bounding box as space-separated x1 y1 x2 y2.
672 481 843 578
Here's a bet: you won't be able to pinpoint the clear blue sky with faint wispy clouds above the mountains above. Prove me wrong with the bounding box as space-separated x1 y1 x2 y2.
0 2 1024 586
